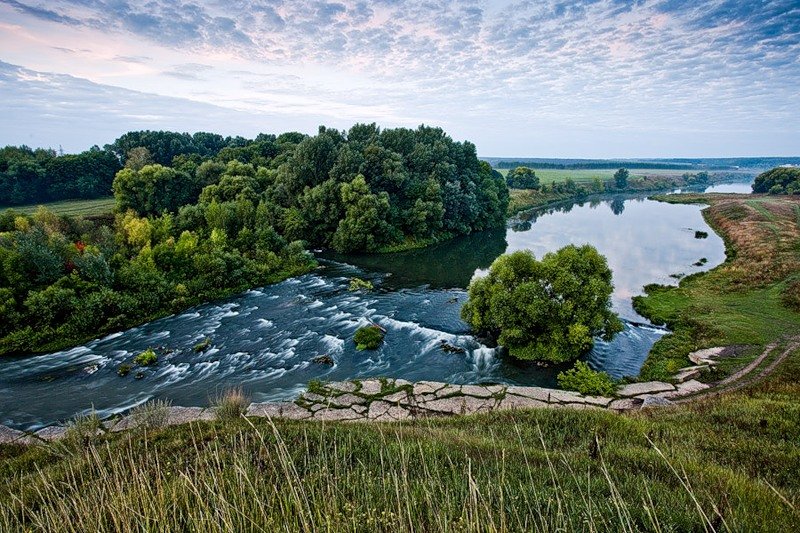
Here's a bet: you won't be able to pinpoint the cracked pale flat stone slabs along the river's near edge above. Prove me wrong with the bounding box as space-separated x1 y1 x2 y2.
0 379 709 444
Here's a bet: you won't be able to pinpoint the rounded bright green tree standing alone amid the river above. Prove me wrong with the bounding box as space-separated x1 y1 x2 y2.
461 245 622 362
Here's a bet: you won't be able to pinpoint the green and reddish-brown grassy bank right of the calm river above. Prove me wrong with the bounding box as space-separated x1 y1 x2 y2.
634 194 800 380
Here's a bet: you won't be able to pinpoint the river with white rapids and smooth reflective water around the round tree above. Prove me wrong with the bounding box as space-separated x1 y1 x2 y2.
0 187 748 429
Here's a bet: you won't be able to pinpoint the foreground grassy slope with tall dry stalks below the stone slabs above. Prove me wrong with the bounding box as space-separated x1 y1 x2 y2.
0 354 800 532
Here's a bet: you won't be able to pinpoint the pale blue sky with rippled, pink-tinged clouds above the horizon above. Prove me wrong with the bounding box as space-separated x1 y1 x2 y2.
0 0 800 158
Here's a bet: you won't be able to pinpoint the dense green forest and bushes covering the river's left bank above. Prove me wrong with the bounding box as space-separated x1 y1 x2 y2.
0 124 509 354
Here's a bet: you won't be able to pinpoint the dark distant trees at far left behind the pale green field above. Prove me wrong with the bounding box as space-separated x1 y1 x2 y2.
0 146 120 206
